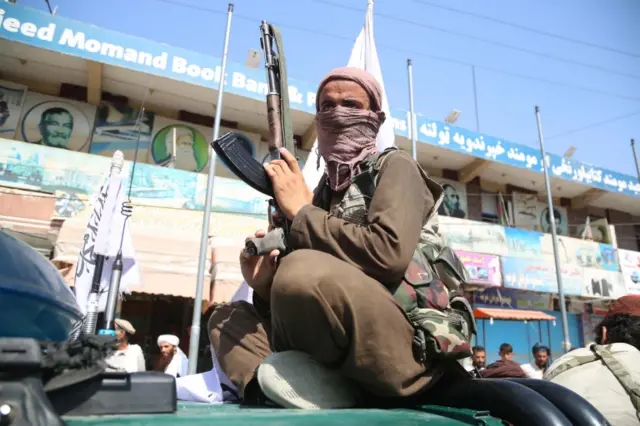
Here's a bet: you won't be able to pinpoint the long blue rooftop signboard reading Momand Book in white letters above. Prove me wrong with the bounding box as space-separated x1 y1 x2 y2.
0 3 640 197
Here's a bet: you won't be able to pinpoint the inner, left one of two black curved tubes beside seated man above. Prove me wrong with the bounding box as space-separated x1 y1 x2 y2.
426 379 582 426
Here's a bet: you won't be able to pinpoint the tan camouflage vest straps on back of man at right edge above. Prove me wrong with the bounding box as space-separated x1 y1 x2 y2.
544 343 640 419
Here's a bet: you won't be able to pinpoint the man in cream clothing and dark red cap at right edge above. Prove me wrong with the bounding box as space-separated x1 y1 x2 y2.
544 295 640 426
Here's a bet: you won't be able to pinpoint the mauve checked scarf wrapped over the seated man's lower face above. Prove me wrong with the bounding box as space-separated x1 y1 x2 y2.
316 106 385 192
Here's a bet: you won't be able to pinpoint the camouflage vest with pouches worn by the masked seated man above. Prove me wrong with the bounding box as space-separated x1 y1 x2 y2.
316 148 476 361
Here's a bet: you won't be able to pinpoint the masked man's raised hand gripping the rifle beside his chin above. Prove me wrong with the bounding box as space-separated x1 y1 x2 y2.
264 148 313 220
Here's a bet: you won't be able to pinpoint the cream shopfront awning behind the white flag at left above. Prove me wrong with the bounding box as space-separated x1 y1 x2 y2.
53 206 211 300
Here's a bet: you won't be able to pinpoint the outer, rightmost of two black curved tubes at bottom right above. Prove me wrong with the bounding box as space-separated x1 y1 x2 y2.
505 379 611 426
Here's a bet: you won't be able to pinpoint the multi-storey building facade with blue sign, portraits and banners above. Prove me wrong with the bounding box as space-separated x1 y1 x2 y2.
0 4 640 362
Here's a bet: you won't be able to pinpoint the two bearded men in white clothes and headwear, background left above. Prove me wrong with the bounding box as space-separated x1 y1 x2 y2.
106 318 189 378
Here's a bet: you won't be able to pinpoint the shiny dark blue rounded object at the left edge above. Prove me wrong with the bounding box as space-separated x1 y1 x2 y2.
0 231 82 341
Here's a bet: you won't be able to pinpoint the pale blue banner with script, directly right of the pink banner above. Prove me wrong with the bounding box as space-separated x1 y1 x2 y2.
501 257 583 296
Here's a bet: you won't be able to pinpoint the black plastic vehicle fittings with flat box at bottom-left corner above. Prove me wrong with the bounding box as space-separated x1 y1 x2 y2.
0 335 177 426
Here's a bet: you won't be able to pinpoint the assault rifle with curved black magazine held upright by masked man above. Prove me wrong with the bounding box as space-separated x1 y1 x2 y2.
211 21 295 256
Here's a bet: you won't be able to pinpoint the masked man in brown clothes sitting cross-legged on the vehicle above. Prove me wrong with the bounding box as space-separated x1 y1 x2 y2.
208 67 474 408
